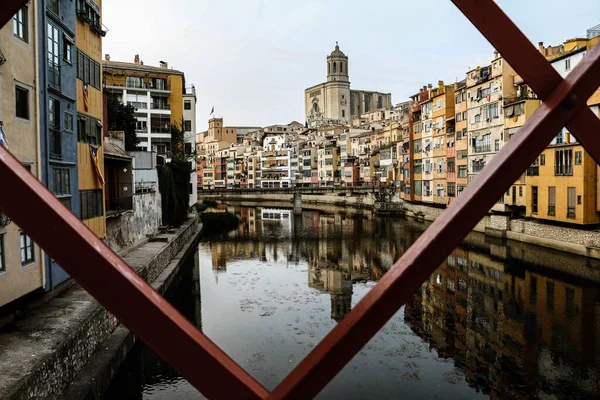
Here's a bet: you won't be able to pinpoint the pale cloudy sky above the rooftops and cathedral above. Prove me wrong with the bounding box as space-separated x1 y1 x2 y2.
102 0 600 132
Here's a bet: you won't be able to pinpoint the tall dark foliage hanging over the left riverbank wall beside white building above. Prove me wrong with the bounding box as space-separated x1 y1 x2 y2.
158 160 192 226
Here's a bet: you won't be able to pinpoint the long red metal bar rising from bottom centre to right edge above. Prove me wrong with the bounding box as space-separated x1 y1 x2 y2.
269 29 600 399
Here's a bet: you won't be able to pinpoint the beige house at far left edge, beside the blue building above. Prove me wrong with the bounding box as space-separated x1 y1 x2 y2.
0 2 46 307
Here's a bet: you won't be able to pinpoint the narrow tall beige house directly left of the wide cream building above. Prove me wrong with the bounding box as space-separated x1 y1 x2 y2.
454 79 469 195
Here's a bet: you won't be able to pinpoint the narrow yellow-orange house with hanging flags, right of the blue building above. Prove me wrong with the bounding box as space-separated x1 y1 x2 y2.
73 0 106 238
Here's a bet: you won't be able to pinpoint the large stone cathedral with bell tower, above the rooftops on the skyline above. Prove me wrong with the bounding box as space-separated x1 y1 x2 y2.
304 42 392 127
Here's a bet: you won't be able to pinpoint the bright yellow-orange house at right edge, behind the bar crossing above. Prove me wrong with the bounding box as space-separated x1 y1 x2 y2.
526 29 600 225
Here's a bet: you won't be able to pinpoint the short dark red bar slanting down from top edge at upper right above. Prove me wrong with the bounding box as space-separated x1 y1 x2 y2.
452 0 600 164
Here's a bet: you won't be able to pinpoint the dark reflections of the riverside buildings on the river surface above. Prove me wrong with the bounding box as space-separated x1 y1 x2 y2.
203 208 600 399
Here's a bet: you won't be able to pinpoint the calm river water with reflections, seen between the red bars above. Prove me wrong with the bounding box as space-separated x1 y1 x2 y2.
105 207 600 399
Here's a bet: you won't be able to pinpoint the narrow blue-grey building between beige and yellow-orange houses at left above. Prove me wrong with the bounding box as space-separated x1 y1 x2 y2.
38 0 79 291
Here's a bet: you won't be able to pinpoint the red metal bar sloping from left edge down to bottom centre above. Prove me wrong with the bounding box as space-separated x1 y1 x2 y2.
0 147 268 399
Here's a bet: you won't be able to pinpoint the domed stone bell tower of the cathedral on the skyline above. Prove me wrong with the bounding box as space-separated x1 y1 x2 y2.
326 42 351 123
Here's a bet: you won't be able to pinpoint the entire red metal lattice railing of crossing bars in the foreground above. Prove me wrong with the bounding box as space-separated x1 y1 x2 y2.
0 0 600 399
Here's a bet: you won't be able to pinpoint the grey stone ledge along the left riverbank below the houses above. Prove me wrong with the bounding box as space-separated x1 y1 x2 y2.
0 218 198 400
